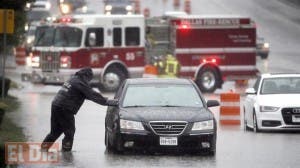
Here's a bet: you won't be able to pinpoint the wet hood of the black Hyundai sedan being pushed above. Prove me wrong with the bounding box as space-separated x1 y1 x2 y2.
120 107 213 122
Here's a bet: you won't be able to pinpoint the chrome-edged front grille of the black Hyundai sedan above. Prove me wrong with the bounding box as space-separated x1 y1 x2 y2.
150 121 187 135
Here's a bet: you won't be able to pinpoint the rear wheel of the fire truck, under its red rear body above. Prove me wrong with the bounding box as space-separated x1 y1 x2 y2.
196 66 219 93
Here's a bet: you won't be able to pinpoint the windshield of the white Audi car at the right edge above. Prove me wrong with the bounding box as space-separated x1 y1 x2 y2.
261 77 300 94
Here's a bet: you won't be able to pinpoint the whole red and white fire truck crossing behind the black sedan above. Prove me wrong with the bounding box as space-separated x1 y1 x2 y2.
27 15 258 92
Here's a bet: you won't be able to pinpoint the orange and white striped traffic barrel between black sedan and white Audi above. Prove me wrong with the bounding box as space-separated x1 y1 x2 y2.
220 92 241 125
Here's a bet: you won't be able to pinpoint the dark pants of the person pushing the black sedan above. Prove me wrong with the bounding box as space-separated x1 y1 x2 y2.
42 105 75 151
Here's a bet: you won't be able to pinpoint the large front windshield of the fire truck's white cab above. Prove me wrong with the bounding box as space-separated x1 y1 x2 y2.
35 26 82 47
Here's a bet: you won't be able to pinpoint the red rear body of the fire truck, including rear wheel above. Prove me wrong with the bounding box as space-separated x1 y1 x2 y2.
164 15 258 92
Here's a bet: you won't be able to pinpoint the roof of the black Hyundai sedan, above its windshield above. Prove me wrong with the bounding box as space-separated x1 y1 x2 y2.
126 78 192 84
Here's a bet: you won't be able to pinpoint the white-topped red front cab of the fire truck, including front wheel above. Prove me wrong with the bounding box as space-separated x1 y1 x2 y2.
31 15 145 90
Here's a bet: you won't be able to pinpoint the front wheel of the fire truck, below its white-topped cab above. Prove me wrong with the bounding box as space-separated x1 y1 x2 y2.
103 67 126 91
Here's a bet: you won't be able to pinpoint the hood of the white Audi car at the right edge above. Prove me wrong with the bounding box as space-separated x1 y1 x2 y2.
258 94 300 107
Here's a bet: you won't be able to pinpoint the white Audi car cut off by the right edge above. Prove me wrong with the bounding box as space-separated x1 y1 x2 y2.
243 74 300 132
